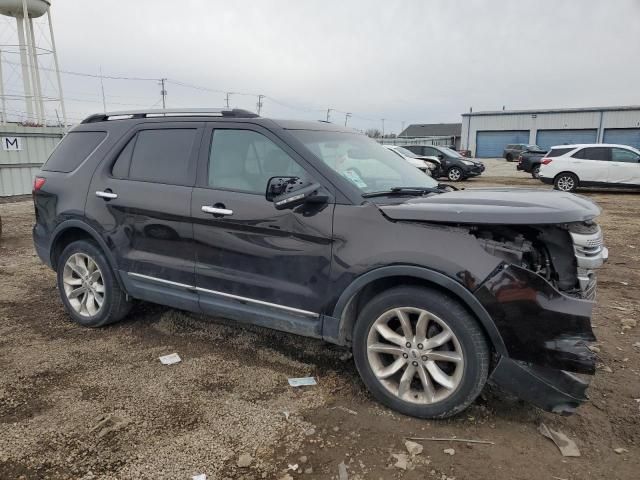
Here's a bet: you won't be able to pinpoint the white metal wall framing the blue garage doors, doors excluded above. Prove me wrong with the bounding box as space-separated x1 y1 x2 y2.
462 108 640 154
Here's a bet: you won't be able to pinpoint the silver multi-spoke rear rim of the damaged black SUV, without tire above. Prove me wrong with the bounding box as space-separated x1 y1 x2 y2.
62 253 105 317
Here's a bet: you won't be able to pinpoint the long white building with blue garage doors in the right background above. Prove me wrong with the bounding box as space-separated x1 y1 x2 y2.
461 106 640 158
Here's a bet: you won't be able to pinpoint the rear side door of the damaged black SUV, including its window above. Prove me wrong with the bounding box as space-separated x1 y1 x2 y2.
86 122 204 308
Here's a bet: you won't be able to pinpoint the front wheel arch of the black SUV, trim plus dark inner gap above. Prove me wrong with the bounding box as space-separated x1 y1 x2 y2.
323 265 507 355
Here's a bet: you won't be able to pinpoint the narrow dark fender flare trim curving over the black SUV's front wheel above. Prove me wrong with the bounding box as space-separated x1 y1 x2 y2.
332 265 507 355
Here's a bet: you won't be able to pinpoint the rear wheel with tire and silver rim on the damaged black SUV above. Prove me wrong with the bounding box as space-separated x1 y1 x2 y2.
57 240 131 328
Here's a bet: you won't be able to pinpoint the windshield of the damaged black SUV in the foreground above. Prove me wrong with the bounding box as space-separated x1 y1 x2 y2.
289 130 437 193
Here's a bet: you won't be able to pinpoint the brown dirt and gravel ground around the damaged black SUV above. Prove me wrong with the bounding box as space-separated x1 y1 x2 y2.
0 176 640 480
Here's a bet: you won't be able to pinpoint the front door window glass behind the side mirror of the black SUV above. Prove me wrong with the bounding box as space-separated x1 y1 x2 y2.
208 129 307 195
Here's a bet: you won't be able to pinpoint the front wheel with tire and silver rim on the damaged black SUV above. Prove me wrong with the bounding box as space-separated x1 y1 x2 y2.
353 287 490 418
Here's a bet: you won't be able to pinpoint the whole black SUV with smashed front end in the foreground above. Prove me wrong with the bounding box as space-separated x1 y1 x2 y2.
33 110 607 418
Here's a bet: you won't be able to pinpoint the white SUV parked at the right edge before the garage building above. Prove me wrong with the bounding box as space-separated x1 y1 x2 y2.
540 143 640 192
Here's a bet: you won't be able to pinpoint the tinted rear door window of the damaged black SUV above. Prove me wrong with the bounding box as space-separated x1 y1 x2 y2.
125 128 196 185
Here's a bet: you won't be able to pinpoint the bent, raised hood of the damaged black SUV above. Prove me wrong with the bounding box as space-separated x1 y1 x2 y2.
378 188 601 225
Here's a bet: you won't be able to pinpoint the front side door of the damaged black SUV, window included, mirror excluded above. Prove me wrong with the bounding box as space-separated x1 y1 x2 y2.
191 123 334 326
